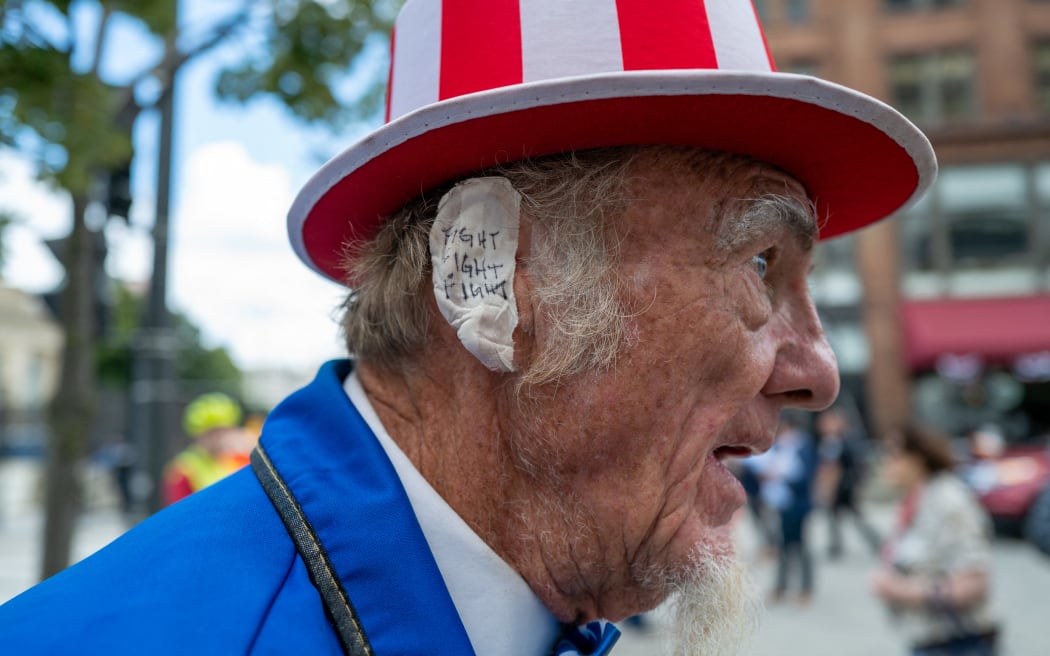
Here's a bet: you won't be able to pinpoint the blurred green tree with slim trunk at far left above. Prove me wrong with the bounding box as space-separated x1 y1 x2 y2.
0 0 400 576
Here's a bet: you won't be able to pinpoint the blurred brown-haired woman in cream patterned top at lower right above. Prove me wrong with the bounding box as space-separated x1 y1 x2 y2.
872 426 998 656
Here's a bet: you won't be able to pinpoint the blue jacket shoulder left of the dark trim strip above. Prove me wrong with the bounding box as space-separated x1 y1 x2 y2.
0 469 338 655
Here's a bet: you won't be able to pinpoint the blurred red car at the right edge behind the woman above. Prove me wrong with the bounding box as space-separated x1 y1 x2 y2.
962 444 1050 533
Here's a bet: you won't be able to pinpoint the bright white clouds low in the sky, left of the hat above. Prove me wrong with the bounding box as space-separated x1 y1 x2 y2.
0 143 343 371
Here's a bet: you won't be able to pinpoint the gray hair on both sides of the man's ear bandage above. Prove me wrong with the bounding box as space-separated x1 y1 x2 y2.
342 148 638 385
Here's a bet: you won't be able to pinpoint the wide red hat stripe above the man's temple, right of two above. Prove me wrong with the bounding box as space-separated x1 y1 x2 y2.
616 0 718 70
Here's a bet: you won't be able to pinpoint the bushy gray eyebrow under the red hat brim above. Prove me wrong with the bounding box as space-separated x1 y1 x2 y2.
717 193 819 253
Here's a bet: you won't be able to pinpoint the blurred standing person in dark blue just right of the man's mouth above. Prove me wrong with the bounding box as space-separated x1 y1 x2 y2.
759 411 818 604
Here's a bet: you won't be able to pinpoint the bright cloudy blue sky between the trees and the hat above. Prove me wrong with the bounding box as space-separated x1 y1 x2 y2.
0 2 383 371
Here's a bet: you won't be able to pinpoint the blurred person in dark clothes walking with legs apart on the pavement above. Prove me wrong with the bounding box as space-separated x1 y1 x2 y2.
817 407 882 559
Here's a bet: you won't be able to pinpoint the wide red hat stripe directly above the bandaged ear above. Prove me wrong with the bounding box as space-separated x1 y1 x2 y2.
439 0 522 100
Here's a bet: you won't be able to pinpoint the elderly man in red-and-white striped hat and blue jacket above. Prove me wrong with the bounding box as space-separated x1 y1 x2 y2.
0 0 936 656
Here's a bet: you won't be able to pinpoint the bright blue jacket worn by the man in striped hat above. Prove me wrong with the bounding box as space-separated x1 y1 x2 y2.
0 361 474 656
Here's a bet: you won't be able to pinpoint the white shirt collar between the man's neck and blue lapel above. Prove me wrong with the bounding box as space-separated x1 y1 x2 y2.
343 369 559 656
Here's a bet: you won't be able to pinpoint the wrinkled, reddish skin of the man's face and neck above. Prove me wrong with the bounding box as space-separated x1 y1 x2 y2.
361 147 838 621
